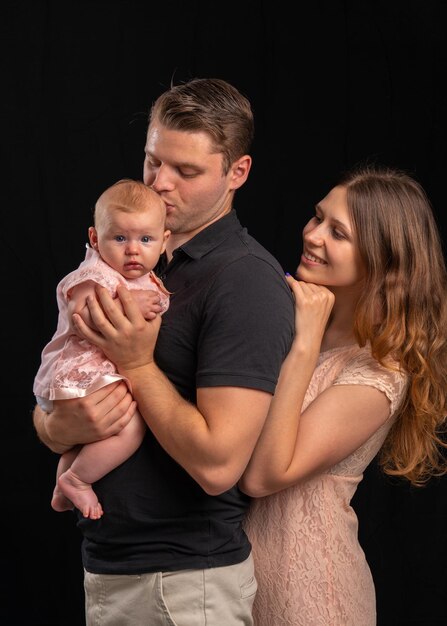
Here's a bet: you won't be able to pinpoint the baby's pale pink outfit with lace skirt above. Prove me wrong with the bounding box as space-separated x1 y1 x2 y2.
33 245 169 411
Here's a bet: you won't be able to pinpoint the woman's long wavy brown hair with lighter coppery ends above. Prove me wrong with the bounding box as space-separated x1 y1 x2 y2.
340 165 447 485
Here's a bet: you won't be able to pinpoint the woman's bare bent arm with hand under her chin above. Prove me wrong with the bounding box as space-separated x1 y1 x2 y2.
239 279 391 497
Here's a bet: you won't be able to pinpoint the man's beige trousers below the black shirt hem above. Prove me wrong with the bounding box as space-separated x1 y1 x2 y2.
84 555 257 626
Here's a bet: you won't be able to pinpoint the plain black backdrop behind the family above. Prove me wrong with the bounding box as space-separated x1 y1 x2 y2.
0 0 447 626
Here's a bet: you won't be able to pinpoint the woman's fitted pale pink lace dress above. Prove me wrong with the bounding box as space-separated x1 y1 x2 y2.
245 346 407 626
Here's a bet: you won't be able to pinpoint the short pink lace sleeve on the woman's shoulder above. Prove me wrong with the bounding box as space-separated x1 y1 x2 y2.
333 350 408 415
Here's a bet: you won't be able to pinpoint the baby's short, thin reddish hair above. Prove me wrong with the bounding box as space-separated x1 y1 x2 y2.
93 178 166 227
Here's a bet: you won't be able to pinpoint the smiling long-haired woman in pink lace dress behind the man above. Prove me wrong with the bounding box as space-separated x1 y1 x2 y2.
240 166 447 626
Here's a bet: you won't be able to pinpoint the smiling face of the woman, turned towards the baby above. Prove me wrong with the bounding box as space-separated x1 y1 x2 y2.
297 186 364 289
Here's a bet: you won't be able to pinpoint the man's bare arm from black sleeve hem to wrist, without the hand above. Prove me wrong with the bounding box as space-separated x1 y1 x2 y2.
117 362 271 495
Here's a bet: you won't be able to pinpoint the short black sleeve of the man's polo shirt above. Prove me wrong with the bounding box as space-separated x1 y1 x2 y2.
196 255 294 393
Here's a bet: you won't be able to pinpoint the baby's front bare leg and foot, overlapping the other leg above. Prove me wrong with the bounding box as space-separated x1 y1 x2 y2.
58 404 146 519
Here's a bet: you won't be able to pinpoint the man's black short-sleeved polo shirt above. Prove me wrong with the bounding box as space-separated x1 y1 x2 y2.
78 211 294 574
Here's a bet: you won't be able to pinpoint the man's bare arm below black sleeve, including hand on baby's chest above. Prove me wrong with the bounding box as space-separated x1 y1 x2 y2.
73 287 271 495
